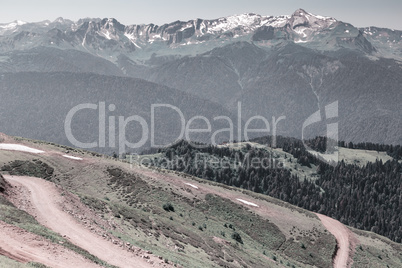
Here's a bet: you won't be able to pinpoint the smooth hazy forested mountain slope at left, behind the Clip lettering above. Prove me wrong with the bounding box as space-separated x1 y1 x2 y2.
0 72 237 153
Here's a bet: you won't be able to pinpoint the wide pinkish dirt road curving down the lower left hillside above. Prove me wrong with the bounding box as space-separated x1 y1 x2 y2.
4 175 162 268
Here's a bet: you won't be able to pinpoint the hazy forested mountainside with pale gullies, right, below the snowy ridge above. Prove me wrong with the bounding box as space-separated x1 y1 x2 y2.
143 42 402 144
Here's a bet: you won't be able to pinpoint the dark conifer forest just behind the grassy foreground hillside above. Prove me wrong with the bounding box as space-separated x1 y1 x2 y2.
154 137 402 243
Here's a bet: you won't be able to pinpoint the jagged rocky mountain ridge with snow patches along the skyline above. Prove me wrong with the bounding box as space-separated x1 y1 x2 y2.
0 9 402 61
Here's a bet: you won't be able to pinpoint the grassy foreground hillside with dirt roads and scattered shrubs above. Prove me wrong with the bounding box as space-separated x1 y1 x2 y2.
0 135 400 267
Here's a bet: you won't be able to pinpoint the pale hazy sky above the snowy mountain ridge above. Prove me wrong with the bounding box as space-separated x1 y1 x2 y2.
0 0 402 30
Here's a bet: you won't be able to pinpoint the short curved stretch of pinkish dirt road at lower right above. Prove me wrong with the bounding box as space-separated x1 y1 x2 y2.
316 213 351 268
